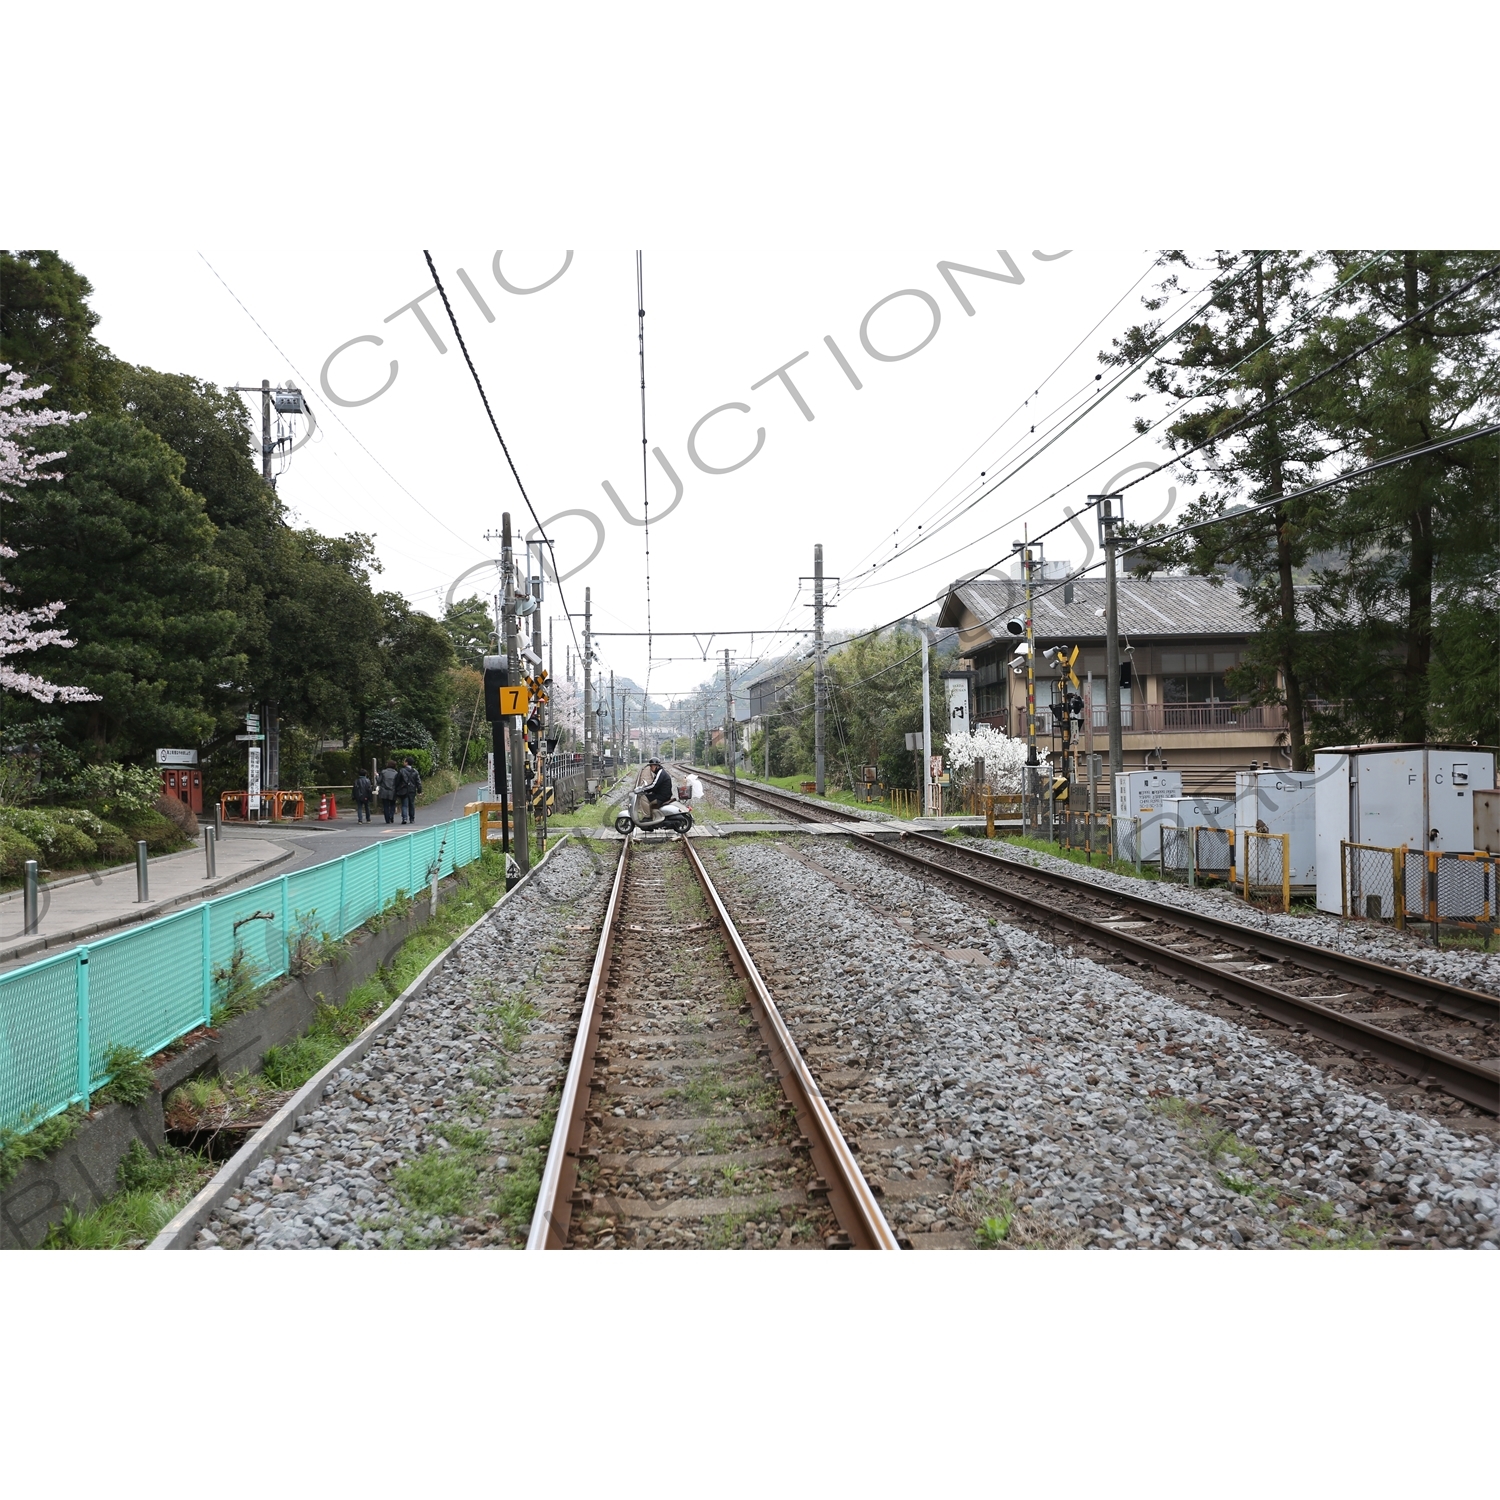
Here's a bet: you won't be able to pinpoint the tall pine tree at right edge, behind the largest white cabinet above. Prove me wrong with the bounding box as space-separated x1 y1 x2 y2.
1305 259 1500 744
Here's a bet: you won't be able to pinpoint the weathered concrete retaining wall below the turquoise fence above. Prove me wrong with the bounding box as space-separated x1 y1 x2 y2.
0 879 455 1250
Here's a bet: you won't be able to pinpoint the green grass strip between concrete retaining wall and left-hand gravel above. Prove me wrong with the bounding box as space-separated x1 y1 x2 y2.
44 848 522 1250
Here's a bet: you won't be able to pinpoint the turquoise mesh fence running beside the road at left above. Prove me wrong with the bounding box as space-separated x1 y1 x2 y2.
0 813 480 1131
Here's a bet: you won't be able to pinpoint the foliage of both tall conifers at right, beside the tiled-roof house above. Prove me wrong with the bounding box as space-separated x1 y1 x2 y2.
1128 251 1500 765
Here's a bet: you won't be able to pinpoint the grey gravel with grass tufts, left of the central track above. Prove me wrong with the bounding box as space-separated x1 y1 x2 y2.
194 840 615 1250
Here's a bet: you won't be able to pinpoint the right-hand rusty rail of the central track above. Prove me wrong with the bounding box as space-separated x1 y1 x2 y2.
683 839 900 1250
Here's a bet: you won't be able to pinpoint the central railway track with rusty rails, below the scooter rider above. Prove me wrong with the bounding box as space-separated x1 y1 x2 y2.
527 840 897 1250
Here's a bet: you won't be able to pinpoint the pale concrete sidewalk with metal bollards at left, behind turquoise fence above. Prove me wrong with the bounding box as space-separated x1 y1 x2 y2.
0 839 293 969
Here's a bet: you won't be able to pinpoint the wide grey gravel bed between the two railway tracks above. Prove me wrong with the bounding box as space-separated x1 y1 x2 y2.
714 837 1500 1250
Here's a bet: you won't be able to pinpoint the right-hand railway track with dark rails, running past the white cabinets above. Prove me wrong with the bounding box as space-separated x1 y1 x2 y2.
699 773 1500 1115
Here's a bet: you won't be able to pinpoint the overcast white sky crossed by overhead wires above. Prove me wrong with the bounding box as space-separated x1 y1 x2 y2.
82 243 1188 692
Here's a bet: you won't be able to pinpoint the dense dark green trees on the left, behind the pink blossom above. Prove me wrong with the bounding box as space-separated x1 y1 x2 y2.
0 252 456 803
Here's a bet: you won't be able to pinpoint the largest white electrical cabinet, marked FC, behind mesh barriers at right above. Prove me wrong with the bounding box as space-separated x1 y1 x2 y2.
1314 744 1496 912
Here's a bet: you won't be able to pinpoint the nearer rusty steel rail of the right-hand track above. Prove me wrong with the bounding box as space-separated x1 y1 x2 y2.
869 839 1500 1115
